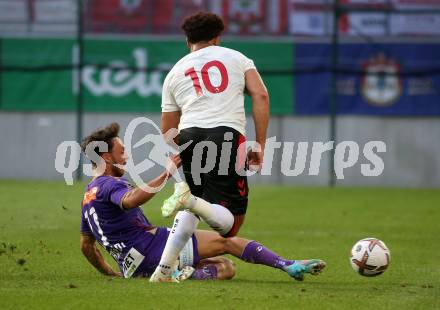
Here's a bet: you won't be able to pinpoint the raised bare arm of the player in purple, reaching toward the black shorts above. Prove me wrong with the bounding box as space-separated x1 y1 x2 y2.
122 155 182 209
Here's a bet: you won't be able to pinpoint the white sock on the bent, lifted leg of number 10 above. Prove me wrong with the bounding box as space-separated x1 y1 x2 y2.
185 195 234 236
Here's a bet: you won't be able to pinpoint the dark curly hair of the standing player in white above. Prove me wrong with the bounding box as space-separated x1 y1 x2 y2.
182 12 225 43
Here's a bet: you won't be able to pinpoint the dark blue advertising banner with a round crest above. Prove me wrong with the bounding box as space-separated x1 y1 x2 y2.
295 43 440 116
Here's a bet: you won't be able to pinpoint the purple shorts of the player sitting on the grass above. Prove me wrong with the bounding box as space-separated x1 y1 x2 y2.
133 227 200 277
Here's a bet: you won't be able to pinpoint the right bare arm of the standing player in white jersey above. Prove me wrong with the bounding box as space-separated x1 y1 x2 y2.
245 69 269 168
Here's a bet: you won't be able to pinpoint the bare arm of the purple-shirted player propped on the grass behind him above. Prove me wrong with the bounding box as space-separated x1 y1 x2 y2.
80 234 122 277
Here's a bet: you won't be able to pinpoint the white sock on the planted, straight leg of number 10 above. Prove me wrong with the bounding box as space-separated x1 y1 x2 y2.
159 211 200 275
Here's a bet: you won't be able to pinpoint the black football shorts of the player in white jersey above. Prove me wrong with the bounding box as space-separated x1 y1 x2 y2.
179 126 249 215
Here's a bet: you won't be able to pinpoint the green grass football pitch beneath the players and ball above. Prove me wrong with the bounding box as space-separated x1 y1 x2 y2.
0 181 440 309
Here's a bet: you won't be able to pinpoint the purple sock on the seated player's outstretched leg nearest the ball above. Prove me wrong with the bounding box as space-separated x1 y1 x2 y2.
241 241 295 270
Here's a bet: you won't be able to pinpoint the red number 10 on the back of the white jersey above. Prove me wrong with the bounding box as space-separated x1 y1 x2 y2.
185 60 229 97
